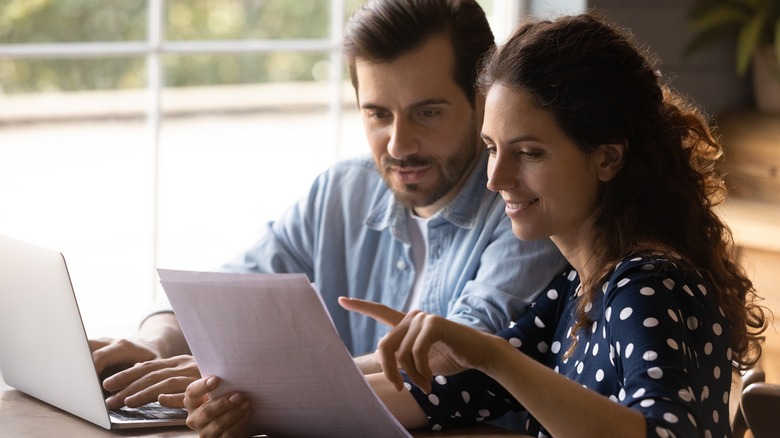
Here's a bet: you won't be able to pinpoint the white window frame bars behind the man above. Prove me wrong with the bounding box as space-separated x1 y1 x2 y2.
0 0 529 314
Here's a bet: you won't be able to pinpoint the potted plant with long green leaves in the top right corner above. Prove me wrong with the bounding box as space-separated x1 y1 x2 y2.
686 0 780 112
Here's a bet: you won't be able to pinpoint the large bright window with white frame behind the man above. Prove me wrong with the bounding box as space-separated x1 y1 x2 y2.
0 0 580 336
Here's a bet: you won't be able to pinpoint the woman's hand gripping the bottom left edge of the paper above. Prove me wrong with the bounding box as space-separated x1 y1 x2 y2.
184 376 252 438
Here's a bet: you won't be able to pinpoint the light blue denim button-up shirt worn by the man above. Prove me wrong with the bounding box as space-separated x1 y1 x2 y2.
223 154 566 355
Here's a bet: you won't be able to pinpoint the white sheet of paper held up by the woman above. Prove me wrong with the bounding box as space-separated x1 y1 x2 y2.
158 269 411 438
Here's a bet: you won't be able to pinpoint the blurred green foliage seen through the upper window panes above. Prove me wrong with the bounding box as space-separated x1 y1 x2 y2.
0 0 361 94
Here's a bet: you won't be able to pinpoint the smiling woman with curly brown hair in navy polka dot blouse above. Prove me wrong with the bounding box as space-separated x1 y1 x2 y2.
187 15 766 437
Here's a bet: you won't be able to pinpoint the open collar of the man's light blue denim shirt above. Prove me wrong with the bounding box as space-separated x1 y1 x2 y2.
363 151 488 243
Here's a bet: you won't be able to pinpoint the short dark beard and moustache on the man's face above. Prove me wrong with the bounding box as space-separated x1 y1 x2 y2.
380 143 479 208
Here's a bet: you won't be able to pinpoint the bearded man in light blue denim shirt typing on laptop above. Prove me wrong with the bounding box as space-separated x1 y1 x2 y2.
93 0 565 407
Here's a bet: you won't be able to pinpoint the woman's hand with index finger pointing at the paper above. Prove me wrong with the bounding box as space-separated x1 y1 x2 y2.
339 297 495 392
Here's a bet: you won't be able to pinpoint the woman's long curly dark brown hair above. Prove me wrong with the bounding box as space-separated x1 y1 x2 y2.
479 14 768 370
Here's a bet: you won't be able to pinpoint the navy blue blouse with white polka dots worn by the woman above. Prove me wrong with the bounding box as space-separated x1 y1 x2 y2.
404 256 731 438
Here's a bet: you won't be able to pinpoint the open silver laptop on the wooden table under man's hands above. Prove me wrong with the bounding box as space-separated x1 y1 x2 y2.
0 235 187 429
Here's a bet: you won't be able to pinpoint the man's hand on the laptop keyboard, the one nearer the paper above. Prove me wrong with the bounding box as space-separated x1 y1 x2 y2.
103 355 200 409
